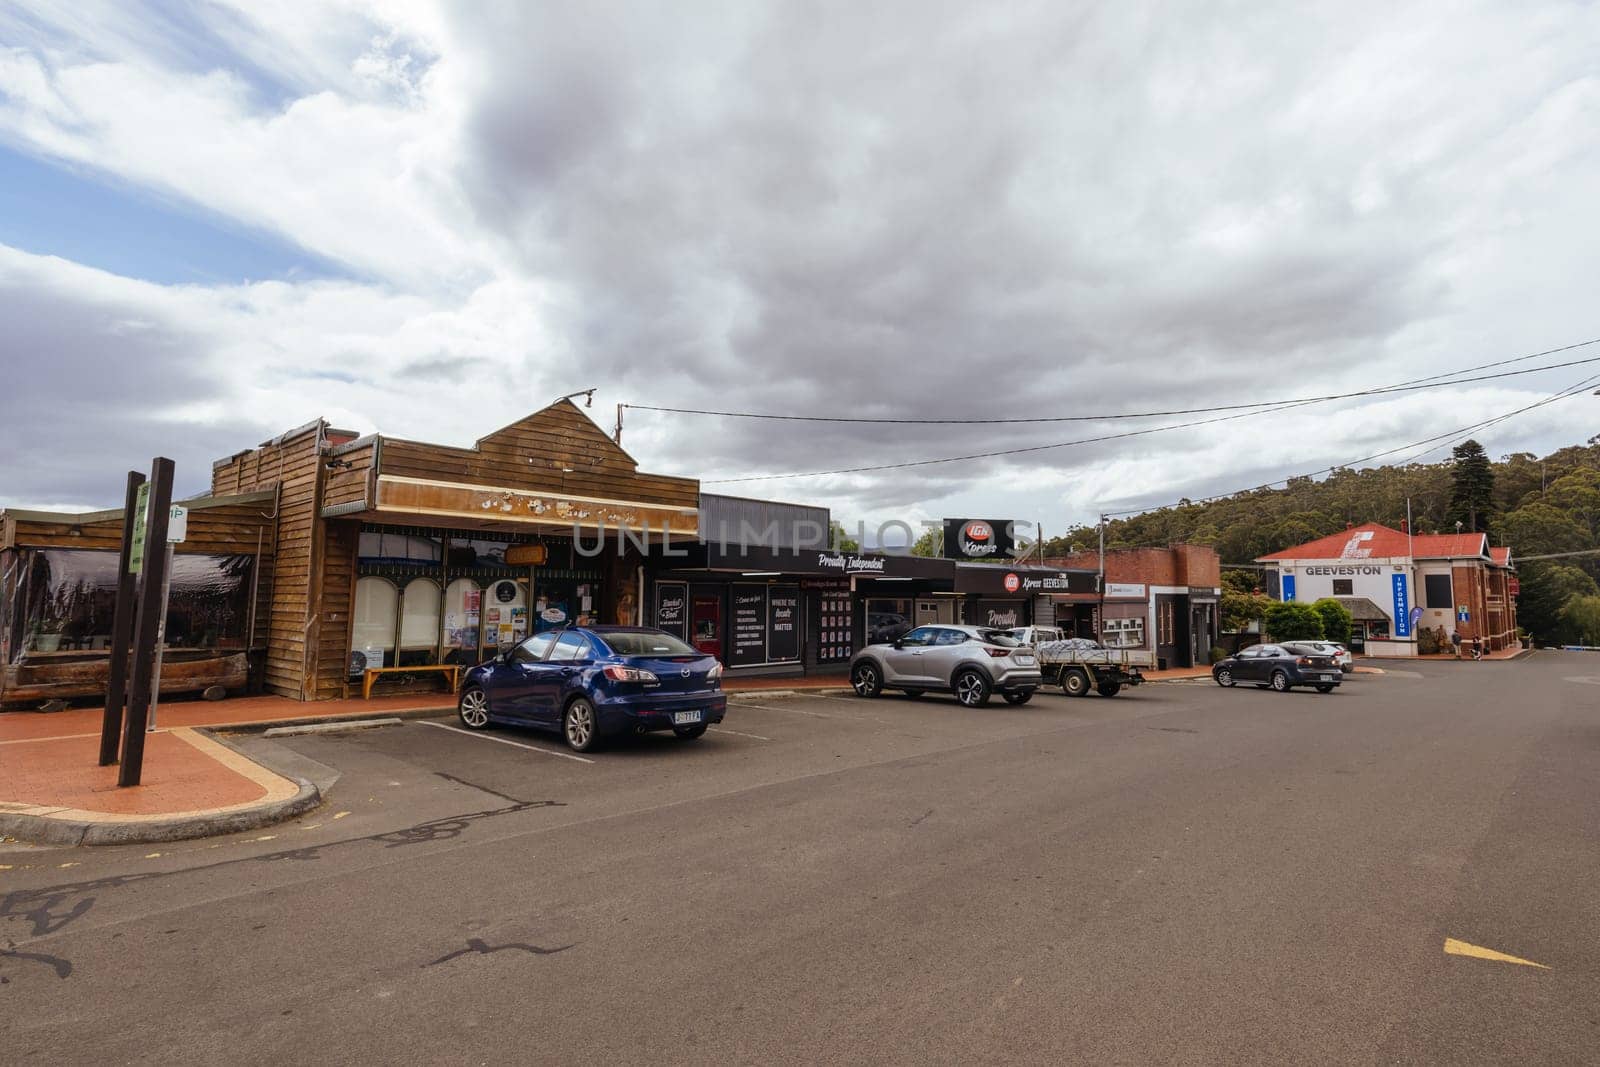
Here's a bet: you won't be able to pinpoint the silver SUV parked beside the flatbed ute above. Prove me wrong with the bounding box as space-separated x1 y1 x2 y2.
850 625 1043 707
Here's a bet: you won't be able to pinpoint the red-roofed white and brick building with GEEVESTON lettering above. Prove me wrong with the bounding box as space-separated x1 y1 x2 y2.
1256 523 1517 656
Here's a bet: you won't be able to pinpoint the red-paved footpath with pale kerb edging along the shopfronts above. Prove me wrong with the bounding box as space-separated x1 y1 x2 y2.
0 667 1273 845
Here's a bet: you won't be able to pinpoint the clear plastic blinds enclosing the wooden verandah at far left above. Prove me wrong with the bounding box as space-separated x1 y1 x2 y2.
0 549 254 662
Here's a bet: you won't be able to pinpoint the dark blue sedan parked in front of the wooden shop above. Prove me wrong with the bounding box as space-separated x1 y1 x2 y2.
458 625 728 752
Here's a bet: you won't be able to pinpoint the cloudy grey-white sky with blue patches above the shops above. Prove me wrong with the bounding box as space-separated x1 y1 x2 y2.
0 0 1600 533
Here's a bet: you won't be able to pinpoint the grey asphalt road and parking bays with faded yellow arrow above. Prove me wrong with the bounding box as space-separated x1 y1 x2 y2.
0 653 1600 1064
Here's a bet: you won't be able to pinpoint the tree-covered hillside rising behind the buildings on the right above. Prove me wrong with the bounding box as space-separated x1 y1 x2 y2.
1045 437 1600 645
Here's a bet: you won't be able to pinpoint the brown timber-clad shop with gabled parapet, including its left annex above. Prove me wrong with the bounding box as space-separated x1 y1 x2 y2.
0 400 699 702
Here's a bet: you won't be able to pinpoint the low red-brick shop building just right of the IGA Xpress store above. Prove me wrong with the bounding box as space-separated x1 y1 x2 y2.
1046 544 1222 667
